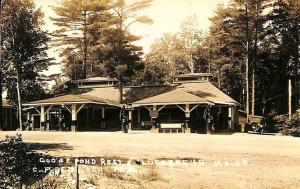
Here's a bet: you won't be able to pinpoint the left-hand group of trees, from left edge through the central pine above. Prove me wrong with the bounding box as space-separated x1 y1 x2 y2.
0 0 152 128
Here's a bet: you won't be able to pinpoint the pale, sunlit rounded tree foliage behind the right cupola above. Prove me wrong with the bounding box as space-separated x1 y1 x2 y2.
143 16 208 84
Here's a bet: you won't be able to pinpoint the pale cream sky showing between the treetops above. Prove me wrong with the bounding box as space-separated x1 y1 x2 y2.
34 0 229 74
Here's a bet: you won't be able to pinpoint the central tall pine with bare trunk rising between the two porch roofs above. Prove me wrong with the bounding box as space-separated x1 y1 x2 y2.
103 0 152 103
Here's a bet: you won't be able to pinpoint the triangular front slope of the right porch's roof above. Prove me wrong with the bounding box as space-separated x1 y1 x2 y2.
133 89 213 106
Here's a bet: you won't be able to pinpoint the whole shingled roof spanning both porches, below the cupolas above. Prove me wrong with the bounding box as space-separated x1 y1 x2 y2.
24 75 240 107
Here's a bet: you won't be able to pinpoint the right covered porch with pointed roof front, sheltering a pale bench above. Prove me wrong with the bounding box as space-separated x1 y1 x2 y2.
129 90 237 133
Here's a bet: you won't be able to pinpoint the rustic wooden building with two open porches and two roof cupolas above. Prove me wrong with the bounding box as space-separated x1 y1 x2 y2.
24 73 239 133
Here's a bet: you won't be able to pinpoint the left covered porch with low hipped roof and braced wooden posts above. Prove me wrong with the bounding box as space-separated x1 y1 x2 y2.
24 95 120 132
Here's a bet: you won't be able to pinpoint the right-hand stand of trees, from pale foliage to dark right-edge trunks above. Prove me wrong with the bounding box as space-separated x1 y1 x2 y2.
144 0 300 117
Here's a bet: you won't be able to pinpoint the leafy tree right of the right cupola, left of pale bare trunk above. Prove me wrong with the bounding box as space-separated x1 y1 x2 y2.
206 5 247 104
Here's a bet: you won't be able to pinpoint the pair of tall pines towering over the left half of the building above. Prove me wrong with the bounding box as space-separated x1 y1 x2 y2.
52 0 152 101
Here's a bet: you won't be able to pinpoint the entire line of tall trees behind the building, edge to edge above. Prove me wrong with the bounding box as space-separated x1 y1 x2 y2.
0 0 300 130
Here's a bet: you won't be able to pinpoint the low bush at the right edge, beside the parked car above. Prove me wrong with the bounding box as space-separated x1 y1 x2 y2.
274 111 300 137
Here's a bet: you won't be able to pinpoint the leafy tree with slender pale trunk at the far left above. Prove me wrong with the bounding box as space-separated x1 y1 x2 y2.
2 0 49 129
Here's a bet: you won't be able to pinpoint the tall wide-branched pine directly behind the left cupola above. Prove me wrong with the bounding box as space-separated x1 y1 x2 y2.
51 0 112 79
